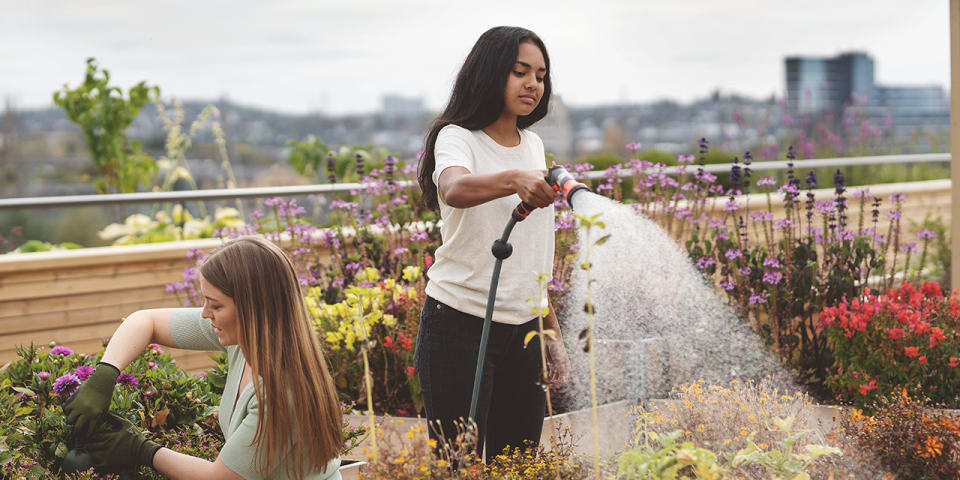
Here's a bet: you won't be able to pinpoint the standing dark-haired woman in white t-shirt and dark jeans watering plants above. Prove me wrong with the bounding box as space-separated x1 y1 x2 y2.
414 27 568 457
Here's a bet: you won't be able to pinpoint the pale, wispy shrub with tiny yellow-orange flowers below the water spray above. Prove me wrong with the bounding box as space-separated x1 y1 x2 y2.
621 380 875 479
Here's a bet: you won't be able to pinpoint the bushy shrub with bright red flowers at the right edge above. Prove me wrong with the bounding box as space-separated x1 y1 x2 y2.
820 282 960 408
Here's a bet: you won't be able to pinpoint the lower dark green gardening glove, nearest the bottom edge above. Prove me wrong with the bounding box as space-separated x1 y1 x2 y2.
85 412 161 468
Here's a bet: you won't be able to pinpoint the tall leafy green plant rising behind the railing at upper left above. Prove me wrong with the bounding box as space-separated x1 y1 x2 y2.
53 58 160 193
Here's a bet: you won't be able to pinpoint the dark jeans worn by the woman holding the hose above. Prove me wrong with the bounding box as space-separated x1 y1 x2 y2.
413 297 546 458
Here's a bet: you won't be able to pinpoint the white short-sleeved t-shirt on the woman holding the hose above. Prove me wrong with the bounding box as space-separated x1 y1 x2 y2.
426 125 554 325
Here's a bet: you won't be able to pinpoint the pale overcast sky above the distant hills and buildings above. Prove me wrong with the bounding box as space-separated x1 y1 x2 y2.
0 0 950 114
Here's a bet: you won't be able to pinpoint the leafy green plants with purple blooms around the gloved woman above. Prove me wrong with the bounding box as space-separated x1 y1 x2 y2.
0 344 366 479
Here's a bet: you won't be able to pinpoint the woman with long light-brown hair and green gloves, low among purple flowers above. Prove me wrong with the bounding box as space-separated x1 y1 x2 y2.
64 237 343 480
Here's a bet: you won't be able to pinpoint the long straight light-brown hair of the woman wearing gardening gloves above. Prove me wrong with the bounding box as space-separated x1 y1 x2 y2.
200 237 343 478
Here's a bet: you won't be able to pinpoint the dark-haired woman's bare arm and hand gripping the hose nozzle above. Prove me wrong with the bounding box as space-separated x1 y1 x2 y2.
437 167 557 208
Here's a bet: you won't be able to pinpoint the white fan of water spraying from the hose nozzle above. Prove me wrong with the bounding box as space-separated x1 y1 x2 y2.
559 192 796 409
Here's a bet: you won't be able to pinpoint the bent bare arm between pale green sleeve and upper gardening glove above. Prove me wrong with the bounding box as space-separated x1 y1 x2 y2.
103 308 177 370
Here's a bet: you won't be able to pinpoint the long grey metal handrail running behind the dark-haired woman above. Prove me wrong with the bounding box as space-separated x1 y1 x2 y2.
0 153 951 211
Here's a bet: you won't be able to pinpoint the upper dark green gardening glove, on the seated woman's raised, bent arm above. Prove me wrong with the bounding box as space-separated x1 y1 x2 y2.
63 362 120 441
